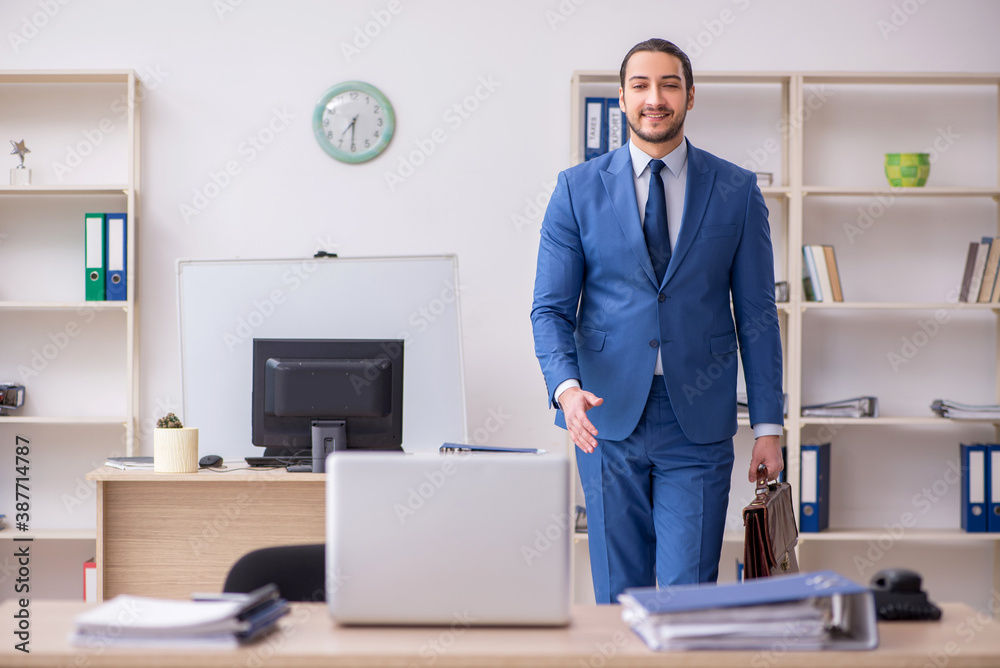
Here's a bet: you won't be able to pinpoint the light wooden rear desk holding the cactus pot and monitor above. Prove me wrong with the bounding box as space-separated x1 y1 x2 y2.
87 462 326 600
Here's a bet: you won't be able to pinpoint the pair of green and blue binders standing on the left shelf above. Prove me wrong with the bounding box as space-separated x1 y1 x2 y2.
84 213 128 302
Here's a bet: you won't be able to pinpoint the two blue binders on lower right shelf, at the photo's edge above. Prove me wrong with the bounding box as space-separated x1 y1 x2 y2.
960 443 1000 533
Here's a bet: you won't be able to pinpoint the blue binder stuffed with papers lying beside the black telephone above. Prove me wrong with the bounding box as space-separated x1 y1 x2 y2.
618 571 878 651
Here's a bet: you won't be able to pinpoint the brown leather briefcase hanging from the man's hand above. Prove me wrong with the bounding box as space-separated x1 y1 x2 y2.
743 482 799 580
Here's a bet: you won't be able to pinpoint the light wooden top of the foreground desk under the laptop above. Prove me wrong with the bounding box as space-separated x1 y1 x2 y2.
0 601 1000 668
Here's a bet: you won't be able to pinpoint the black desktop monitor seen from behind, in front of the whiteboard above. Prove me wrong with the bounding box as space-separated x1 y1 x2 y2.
251 339 403 472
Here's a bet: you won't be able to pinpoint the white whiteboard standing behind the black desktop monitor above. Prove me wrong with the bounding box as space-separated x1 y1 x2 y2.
177 256 468 458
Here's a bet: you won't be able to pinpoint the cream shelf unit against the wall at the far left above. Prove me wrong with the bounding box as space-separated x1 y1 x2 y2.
0 70 141 556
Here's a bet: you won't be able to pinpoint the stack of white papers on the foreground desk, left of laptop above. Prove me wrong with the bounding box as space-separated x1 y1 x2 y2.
73 585 288 647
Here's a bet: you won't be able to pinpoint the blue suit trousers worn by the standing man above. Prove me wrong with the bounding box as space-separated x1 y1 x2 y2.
576 376 733 603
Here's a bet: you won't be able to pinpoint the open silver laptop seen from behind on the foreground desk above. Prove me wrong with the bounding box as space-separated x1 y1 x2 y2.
326 452 573 628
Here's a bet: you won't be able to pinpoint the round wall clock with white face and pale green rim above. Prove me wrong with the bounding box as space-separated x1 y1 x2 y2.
313 81 396 163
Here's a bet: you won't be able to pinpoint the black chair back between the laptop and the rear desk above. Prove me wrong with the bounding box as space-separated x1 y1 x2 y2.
222 544 326 602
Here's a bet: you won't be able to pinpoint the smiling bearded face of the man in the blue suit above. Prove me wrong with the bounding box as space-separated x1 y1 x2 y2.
618 51 694 153
